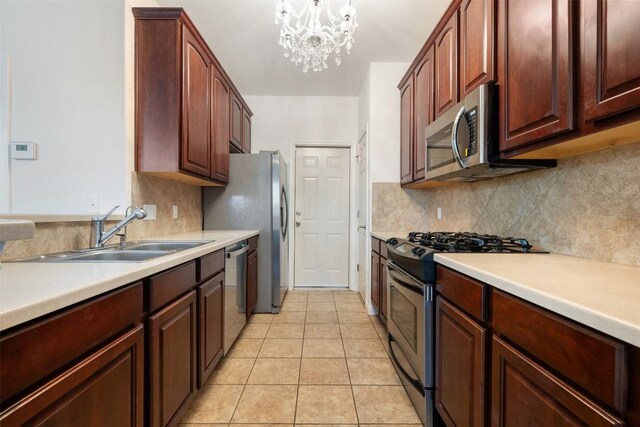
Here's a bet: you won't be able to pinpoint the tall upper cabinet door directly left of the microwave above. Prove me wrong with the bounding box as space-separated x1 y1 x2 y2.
412 47 434 181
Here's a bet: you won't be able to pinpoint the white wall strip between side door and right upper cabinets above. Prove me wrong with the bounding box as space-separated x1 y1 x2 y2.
369 62 410 182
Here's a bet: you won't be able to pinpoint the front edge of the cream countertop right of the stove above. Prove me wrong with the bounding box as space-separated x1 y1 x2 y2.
434 254 640 347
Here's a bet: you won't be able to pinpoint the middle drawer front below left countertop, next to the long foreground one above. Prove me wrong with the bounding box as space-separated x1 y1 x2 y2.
147 261 196 313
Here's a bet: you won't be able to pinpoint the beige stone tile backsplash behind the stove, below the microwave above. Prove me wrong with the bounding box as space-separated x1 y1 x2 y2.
372 143 640 265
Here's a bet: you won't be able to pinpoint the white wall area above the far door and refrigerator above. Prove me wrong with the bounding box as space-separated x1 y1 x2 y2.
244 96 358 163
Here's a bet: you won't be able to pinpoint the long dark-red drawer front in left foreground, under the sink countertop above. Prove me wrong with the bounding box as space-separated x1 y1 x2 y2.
0 283 143 406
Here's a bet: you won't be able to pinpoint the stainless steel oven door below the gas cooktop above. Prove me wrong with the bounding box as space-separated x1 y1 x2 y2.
387 261 431 388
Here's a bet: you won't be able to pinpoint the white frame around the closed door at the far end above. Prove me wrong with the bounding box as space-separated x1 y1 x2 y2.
289 140 358 291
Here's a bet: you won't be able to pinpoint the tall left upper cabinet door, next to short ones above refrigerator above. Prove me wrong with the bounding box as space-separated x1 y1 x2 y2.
211 65 230 182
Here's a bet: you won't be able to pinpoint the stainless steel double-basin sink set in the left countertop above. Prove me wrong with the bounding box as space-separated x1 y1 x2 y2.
6 240 213 262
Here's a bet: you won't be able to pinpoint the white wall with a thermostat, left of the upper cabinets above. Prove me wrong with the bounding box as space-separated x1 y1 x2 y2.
0 0 130 215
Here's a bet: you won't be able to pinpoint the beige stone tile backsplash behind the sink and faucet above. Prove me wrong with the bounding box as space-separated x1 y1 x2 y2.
2 172 202 261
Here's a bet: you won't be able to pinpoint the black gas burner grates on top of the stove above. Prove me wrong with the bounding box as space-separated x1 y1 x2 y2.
408 232 533 253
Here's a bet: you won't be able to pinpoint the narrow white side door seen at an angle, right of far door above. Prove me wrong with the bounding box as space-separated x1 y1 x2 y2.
356 132 369 301
